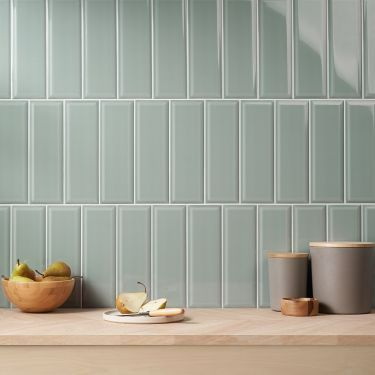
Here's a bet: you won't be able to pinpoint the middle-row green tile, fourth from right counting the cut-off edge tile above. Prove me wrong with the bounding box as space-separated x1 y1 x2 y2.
241 101 274 203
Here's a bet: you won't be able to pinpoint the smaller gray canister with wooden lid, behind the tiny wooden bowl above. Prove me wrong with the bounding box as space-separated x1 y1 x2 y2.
268 253 308 311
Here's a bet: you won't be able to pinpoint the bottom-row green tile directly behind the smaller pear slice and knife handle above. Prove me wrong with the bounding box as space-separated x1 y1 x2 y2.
153 206 186 306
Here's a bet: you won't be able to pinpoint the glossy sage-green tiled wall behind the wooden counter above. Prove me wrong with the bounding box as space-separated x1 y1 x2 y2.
0 0 375 307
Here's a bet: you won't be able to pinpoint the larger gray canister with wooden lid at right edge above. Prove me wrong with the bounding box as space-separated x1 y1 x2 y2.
310 242 374 314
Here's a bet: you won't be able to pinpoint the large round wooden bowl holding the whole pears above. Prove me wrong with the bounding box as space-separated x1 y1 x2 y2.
2 278 75 312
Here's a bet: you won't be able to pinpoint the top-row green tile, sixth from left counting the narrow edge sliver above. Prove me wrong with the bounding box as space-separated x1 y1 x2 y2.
154 0 186 98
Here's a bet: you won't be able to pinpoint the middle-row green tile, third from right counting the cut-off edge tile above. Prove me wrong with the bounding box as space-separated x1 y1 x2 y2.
276 101 309 203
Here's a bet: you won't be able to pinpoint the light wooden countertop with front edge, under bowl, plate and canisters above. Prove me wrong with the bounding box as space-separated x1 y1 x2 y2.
0 309 375 346
